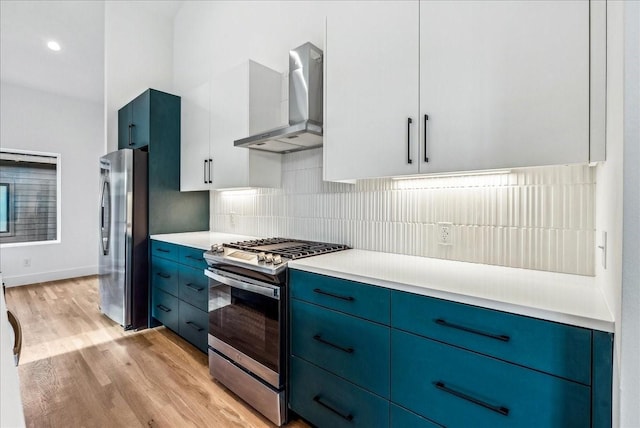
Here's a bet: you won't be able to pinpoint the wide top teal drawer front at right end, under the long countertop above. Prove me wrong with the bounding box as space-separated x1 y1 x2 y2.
391 291 591 385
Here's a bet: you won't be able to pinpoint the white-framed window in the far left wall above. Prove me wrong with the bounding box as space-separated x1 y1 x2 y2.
0 149 60 246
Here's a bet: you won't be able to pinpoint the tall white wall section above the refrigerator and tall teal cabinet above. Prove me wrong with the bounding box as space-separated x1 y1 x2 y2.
104 1 173 153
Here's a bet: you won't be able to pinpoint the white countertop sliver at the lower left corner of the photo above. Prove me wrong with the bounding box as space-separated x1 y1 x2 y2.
0 275 25 427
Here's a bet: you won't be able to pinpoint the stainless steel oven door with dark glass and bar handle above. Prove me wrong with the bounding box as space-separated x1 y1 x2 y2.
205 267 284 389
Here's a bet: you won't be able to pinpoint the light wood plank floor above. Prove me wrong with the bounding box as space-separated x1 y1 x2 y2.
6 277 307 428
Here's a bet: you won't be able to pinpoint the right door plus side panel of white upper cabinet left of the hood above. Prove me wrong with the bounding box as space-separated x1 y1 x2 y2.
210 61 282 189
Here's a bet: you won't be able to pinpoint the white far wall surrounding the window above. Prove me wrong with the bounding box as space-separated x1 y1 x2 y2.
0 82 104 286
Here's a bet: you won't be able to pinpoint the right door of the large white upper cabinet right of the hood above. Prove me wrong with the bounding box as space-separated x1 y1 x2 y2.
420 0 589 173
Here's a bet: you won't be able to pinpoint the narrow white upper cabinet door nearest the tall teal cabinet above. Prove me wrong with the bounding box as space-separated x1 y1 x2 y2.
180 82 210 192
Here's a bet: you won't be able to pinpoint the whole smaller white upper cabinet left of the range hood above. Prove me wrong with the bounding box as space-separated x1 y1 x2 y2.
181 61 282 191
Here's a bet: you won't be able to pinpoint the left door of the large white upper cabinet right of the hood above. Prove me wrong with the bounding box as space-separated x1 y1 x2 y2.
323 1 419 181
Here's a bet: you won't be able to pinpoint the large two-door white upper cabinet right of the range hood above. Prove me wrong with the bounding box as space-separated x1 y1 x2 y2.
324 0 604 180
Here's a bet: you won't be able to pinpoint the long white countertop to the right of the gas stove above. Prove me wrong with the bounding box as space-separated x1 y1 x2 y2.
289 250 614 332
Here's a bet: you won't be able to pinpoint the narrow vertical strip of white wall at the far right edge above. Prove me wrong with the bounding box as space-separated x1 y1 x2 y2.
620 2 640 427
